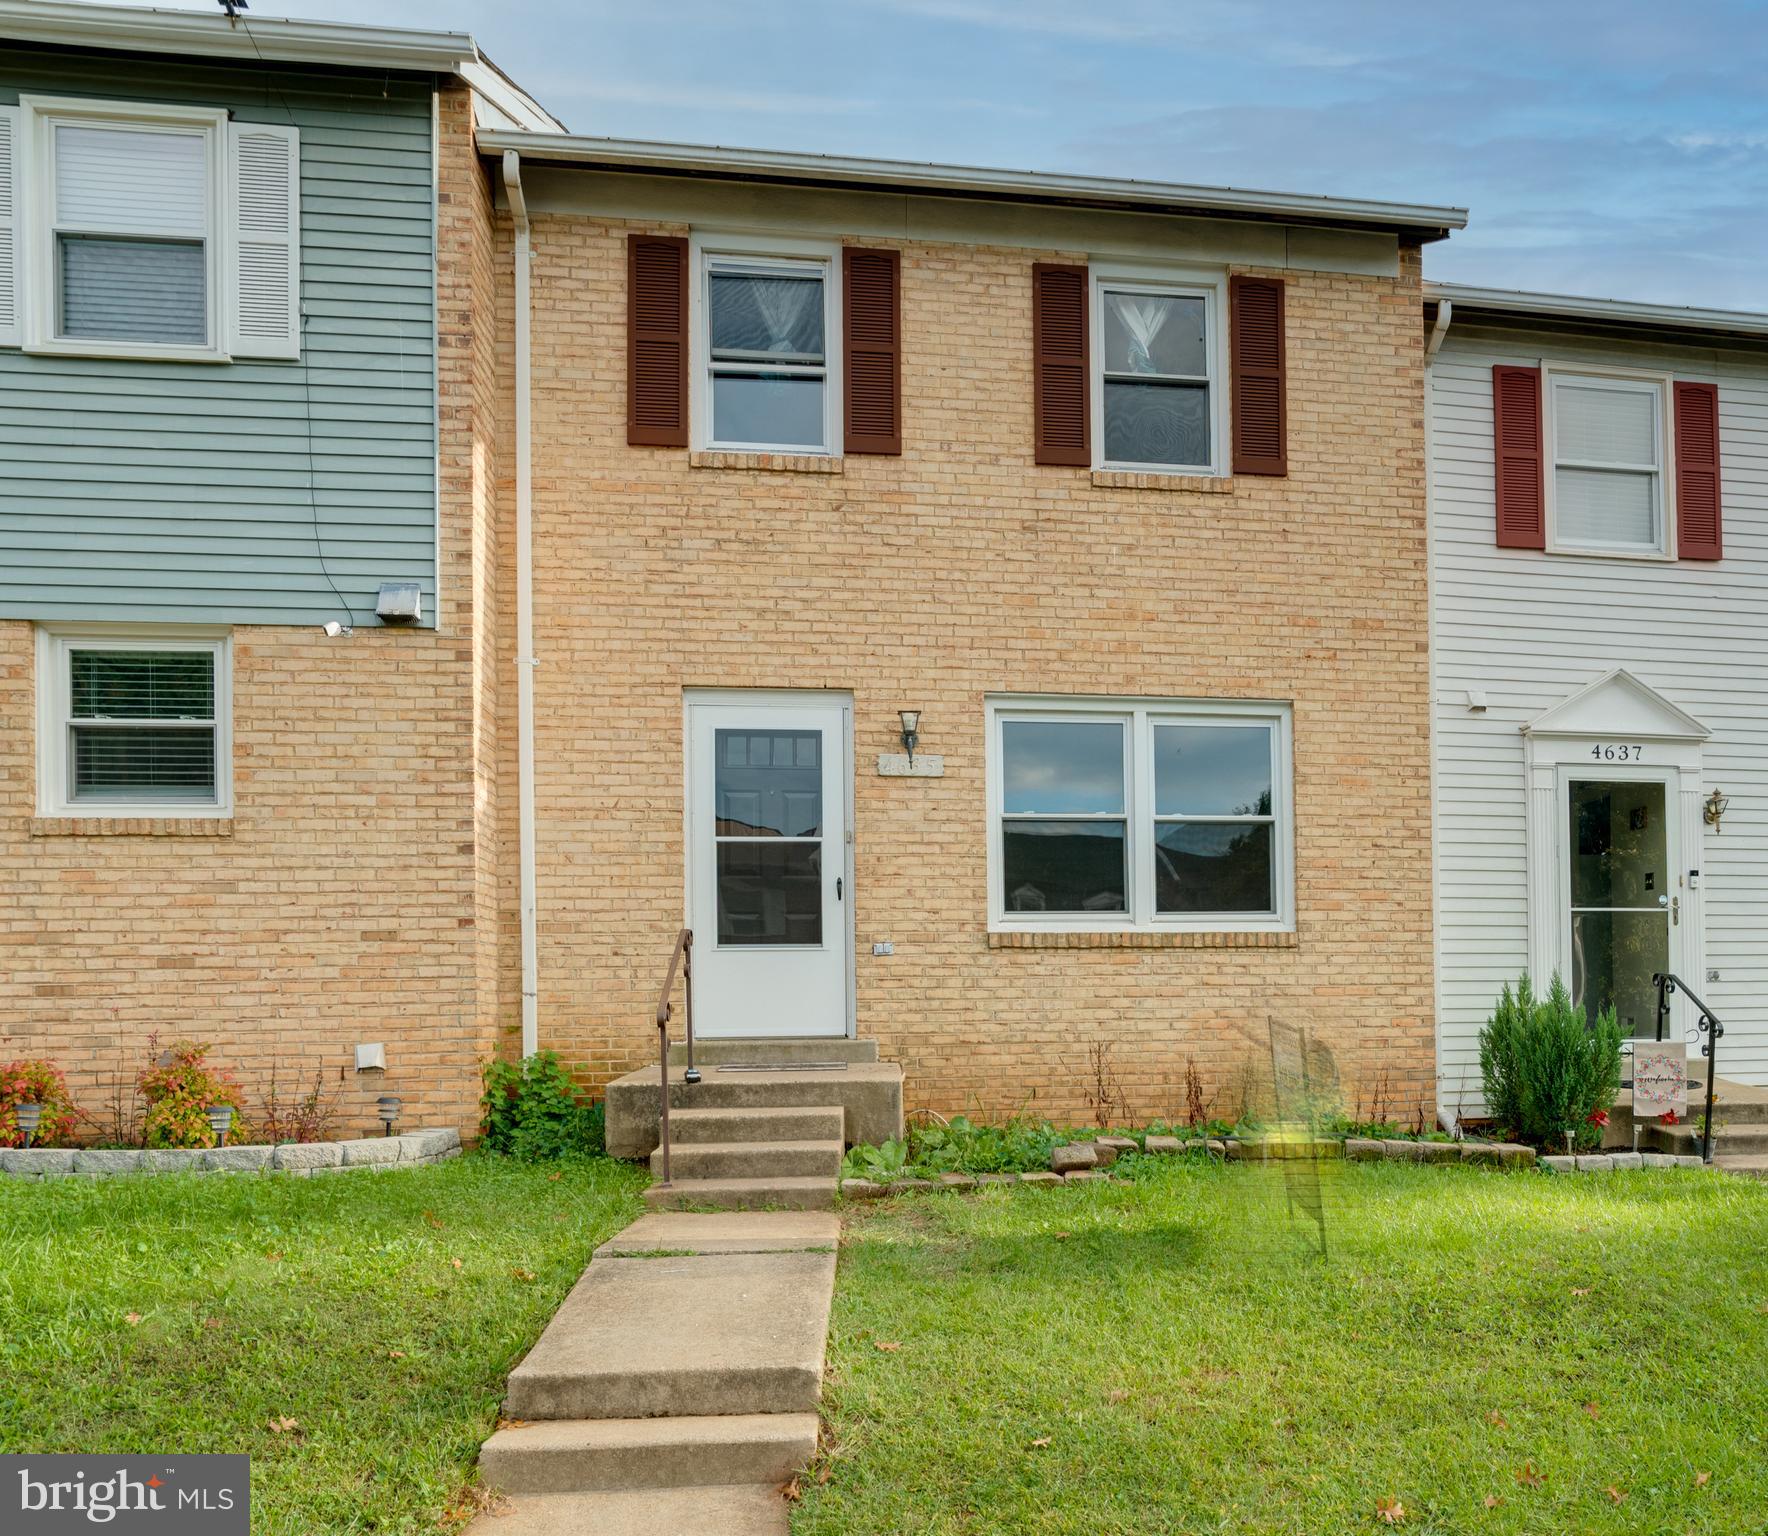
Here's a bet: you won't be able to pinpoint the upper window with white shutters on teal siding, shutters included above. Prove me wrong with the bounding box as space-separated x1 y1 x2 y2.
0 95 301 362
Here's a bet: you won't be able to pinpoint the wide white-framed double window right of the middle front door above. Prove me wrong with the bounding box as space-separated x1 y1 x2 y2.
988 698 1294 930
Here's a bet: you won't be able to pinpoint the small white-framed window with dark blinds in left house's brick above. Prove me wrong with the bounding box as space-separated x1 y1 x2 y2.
37 629 232 817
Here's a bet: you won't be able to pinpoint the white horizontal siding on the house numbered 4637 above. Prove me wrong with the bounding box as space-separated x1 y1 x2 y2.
1429 322 1768 1114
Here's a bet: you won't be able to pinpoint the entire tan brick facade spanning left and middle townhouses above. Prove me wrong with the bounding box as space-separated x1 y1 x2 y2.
0 104 1434 1129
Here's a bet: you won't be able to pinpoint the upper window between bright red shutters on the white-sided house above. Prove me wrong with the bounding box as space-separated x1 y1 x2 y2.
1547 368 1673 557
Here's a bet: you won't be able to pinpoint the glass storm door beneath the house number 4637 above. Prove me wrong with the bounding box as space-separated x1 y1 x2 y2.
1566 778 1681 1036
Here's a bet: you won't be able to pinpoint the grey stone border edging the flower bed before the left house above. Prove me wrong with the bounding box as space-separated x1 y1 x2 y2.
0 1129 460 1179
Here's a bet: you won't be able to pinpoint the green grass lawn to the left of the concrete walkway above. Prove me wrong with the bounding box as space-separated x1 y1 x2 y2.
0 1156 645 1536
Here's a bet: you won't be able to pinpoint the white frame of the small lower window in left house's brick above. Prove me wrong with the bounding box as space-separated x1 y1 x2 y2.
37 624 233 820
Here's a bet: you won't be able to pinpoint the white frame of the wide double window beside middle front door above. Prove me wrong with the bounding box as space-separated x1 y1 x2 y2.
985 695 1296 933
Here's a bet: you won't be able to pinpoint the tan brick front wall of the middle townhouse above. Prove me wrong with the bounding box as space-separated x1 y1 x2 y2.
500 214 1434 1117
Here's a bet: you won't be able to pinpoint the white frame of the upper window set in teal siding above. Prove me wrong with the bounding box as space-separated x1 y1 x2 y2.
19 95 232 362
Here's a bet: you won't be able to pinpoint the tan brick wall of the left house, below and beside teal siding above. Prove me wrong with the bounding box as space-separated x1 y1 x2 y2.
0 83 499 1133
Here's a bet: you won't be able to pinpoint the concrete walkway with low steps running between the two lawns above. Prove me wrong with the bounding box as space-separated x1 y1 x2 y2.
470 1211 840 1536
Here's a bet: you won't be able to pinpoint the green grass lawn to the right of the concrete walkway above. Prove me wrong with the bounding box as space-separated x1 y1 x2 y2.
792 1160 1768 1536
